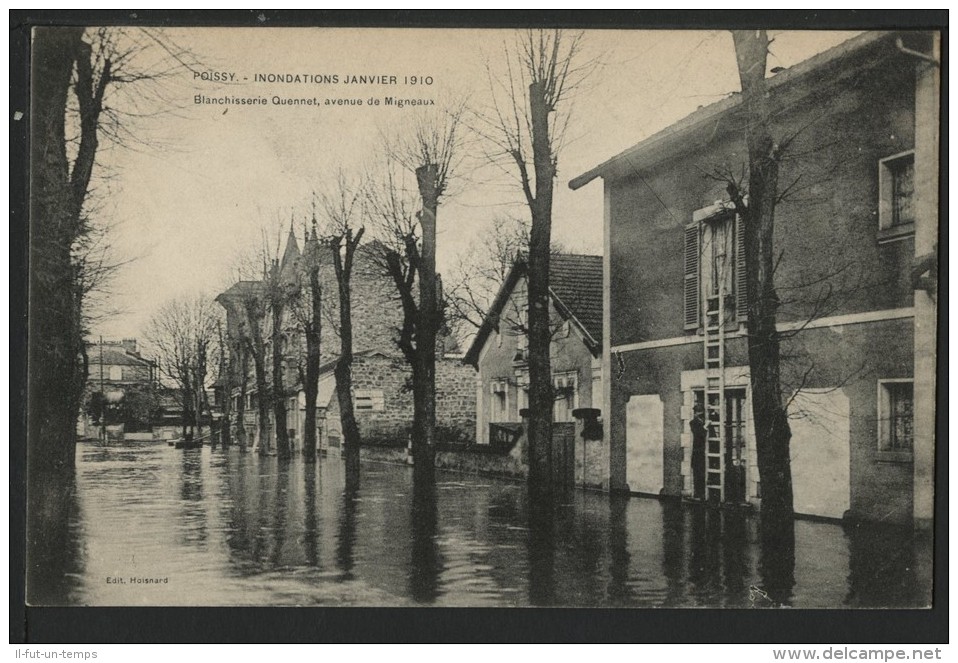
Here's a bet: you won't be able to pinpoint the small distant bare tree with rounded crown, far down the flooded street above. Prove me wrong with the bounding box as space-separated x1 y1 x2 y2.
146 295 221 437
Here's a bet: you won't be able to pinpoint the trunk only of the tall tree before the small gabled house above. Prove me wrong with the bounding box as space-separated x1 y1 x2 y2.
528 83 555 498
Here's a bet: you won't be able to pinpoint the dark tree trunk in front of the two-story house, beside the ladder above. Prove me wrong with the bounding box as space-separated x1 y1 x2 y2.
732 30 793 529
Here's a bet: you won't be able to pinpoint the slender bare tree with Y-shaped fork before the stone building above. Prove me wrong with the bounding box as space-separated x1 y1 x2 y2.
322 171 366 486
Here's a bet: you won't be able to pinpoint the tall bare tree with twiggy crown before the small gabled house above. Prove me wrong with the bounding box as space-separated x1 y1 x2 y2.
477 30 596 493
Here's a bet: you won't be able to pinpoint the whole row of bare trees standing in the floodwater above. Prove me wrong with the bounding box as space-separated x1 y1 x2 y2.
29 28 804 524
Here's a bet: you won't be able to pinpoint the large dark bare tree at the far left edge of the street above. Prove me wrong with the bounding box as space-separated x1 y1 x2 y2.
28 27 196 476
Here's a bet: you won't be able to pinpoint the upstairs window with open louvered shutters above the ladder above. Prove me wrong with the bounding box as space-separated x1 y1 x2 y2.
683 203 748 330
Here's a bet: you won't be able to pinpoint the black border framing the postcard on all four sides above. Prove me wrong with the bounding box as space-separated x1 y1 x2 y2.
8 10 949 644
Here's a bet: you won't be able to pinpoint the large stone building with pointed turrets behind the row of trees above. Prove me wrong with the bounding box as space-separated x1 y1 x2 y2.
217 228 475 450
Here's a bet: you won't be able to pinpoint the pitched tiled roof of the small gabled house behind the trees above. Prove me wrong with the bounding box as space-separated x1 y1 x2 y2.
463 253 602 366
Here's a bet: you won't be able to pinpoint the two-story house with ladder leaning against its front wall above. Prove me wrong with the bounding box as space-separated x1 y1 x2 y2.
570 32 940 523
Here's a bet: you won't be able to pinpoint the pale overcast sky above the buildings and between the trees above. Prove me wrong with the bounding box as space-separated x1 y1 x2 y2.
84 28 854 338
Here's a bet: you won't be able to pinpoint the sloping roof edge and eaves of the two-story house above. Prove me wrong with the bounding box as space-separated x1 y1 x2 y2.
569 31 898 190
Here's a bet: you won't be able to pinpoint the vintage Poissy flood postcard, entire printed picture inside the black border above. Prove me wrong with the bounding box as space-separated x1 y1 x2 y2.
24 24 941 608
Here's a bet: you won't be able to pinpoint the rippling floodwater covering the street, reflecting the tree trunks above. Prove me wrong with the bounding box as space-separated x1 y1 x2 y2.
28 443 932 608
